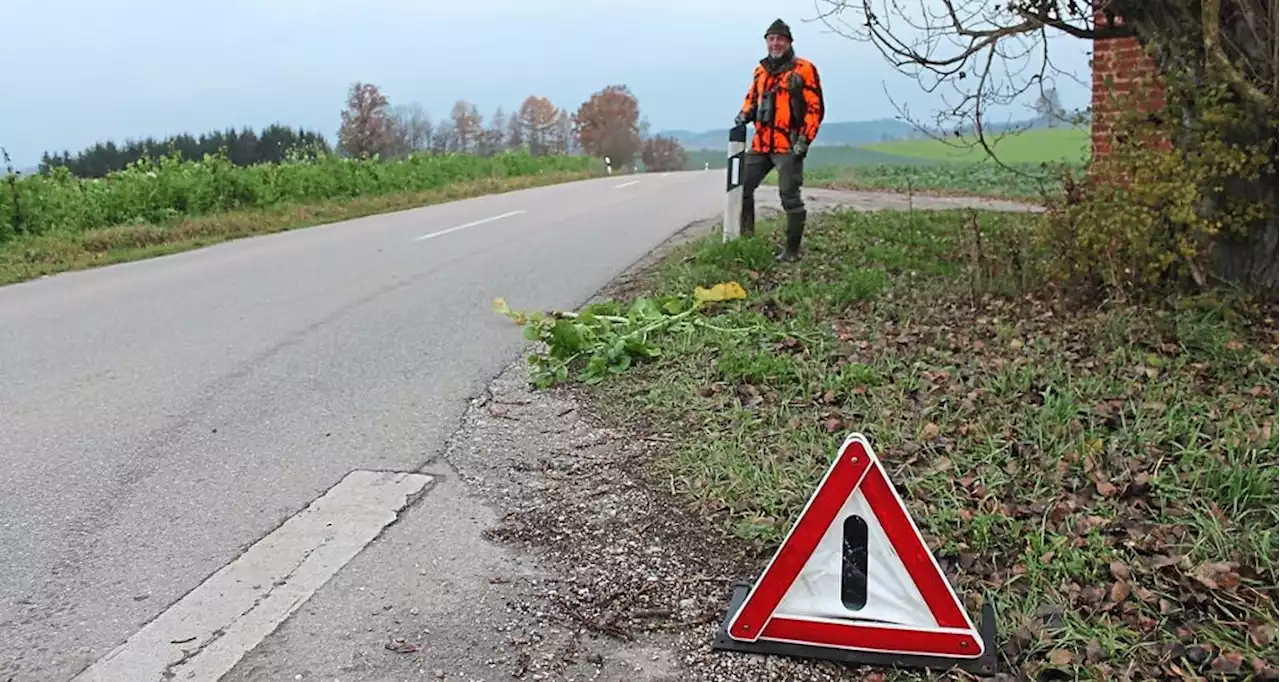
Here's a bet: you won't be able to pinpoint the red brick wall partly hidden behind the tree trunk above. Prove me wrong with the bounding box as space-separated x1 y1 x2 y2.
1092 15 1164 160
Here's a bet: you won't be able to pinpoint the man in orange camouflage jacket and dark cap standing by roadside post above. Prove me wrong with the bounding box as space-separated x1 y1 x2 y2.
733 19 826 261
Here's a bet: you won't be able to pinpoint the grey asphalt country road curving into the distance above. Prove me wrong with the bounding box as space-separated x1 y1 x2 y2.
0 171 723 682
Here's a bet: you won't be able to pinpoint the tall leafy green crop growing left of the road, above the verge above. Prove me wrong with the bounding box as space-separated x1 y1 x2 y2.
0 152 591 242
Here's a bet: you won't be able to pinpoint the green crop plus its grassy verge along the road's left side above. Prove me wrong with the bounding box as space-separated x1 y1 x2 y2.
0 152 593 284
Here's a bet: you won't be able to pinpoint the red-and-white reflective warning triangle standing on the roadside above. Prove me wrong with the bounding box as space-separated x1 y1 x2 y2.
717 434 995 667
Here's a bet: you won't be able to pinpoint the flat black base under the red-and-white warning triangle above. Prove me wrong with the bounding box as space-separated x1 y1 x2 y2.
712 583 997 676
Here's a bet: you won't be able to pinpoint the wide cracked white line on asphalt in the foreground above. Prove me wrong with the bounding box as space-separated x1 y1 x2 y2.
72 471 434 682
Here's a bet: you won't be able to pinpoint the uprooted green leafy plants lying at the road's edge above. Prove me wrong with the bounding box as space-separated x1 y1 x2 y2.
493 282 750 388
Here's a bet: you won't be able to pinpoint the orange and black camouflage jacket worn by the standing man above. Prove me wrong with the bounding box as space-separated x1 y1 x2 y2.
741 56 826 154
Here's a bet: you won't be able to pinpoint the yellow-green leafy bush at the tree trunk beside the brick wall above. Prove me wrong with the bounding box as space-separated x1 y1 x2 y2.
1042 69 1276 298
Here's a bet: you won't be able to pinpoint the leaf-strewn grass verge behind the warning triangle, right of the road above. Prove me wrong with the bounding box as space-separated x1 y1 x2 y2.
550 211 1280 681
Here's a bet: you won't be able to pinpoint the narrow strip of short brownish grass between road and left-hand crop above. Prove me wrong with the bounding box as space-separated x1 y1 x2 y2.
0 171 594 285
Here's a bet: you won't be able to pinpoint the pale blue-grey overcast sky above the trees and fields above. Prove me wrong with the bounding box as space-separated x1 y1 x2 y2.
0 0 1088 166
